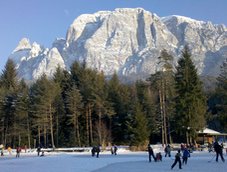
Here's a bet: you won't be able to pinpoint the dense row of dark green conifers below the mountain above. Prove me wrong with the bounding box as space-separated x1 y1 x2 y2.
0 46 227 148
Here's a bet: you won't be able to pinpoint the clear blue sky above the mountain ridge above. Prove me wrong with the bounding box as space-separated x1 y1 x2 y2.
0 0 227 73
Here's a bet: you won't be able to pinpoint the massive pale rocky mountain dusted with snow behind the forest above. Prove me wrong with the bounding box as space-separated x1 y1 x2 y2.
10 8 227 80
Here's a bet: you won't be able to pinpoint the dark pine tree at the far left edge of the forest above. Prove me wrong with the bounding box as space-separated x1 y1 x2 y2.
0 59 18 145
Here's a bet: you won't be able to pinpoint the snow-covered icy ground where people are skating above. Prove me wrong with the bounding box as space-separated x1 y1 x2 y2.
0 150 227 172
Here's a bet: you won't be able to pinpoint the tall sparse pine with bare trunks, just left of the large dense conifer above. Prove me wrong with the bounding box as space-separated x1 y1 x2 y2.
148 50 175 144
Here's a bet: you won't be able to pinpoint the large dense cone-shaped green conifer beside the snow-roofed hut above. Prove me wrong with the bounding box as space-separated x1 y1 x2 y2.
173 46 206 143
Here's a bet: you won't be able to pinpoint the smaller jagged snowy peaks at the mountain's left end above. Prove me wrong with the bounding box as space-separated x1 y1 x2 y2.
9 38 65 81
